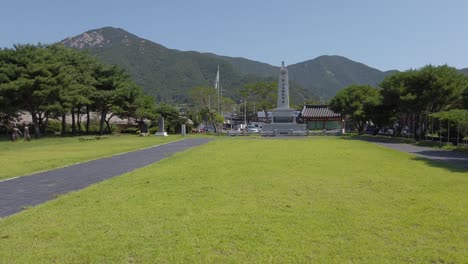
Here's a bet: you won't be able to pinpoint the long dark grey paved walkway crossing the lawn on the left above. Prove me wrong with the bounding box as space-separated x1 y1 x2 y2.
0 138 211 217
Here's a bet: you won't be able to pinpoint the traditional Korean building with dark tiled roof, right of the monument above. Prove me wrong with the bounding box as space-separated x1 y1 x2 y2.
301 105 344 130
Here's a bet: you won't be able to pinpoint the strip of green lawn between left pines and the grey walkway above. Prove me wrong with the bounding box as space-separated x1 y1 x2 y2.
0 135 181 180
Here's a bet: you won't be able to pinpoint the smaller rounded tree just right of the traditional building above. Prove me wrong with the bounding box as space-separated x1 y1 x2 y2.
330 85 380 134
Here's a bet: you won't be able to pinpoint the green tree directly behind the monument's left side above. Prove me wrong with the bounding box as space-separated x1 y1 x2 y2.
241 81 278 123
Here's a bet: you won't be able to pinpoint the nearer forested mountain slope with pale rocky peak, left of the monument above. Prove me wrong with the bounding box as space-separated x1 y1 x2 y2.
62 27 242 102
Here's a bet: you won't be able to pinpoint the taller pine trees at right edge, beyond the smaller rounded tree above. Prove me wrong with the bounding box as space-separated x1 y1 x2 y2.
380 65 468 138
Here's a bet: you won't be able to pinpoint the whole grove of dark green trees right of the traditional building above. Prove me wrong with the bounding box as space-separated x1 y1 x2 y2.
330 65 468 137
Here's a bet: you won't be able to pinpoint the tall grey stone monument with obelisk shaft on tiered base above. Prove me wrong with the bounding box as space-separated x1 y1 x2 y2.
261 61 307 136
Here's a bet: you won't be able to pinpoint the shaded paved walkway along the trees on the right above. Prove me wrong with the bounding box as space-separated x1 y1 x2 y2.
359 137 468 169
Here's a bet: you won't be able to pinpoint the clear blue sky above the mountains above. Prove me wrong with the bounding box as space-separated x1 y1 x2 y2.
0 0 468 70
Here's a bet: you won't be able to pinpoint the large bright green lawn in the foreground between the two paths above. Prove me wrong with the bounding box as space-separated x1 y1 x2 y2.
0 138 468 263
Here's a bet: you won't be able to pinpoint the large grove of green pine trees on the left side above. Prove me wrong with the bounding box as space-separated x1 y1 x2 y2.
0 44 156 137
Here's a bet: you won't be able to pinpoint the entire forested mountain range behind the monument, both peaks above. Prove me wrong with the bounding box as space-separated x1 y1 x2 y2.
62 27 398 103
